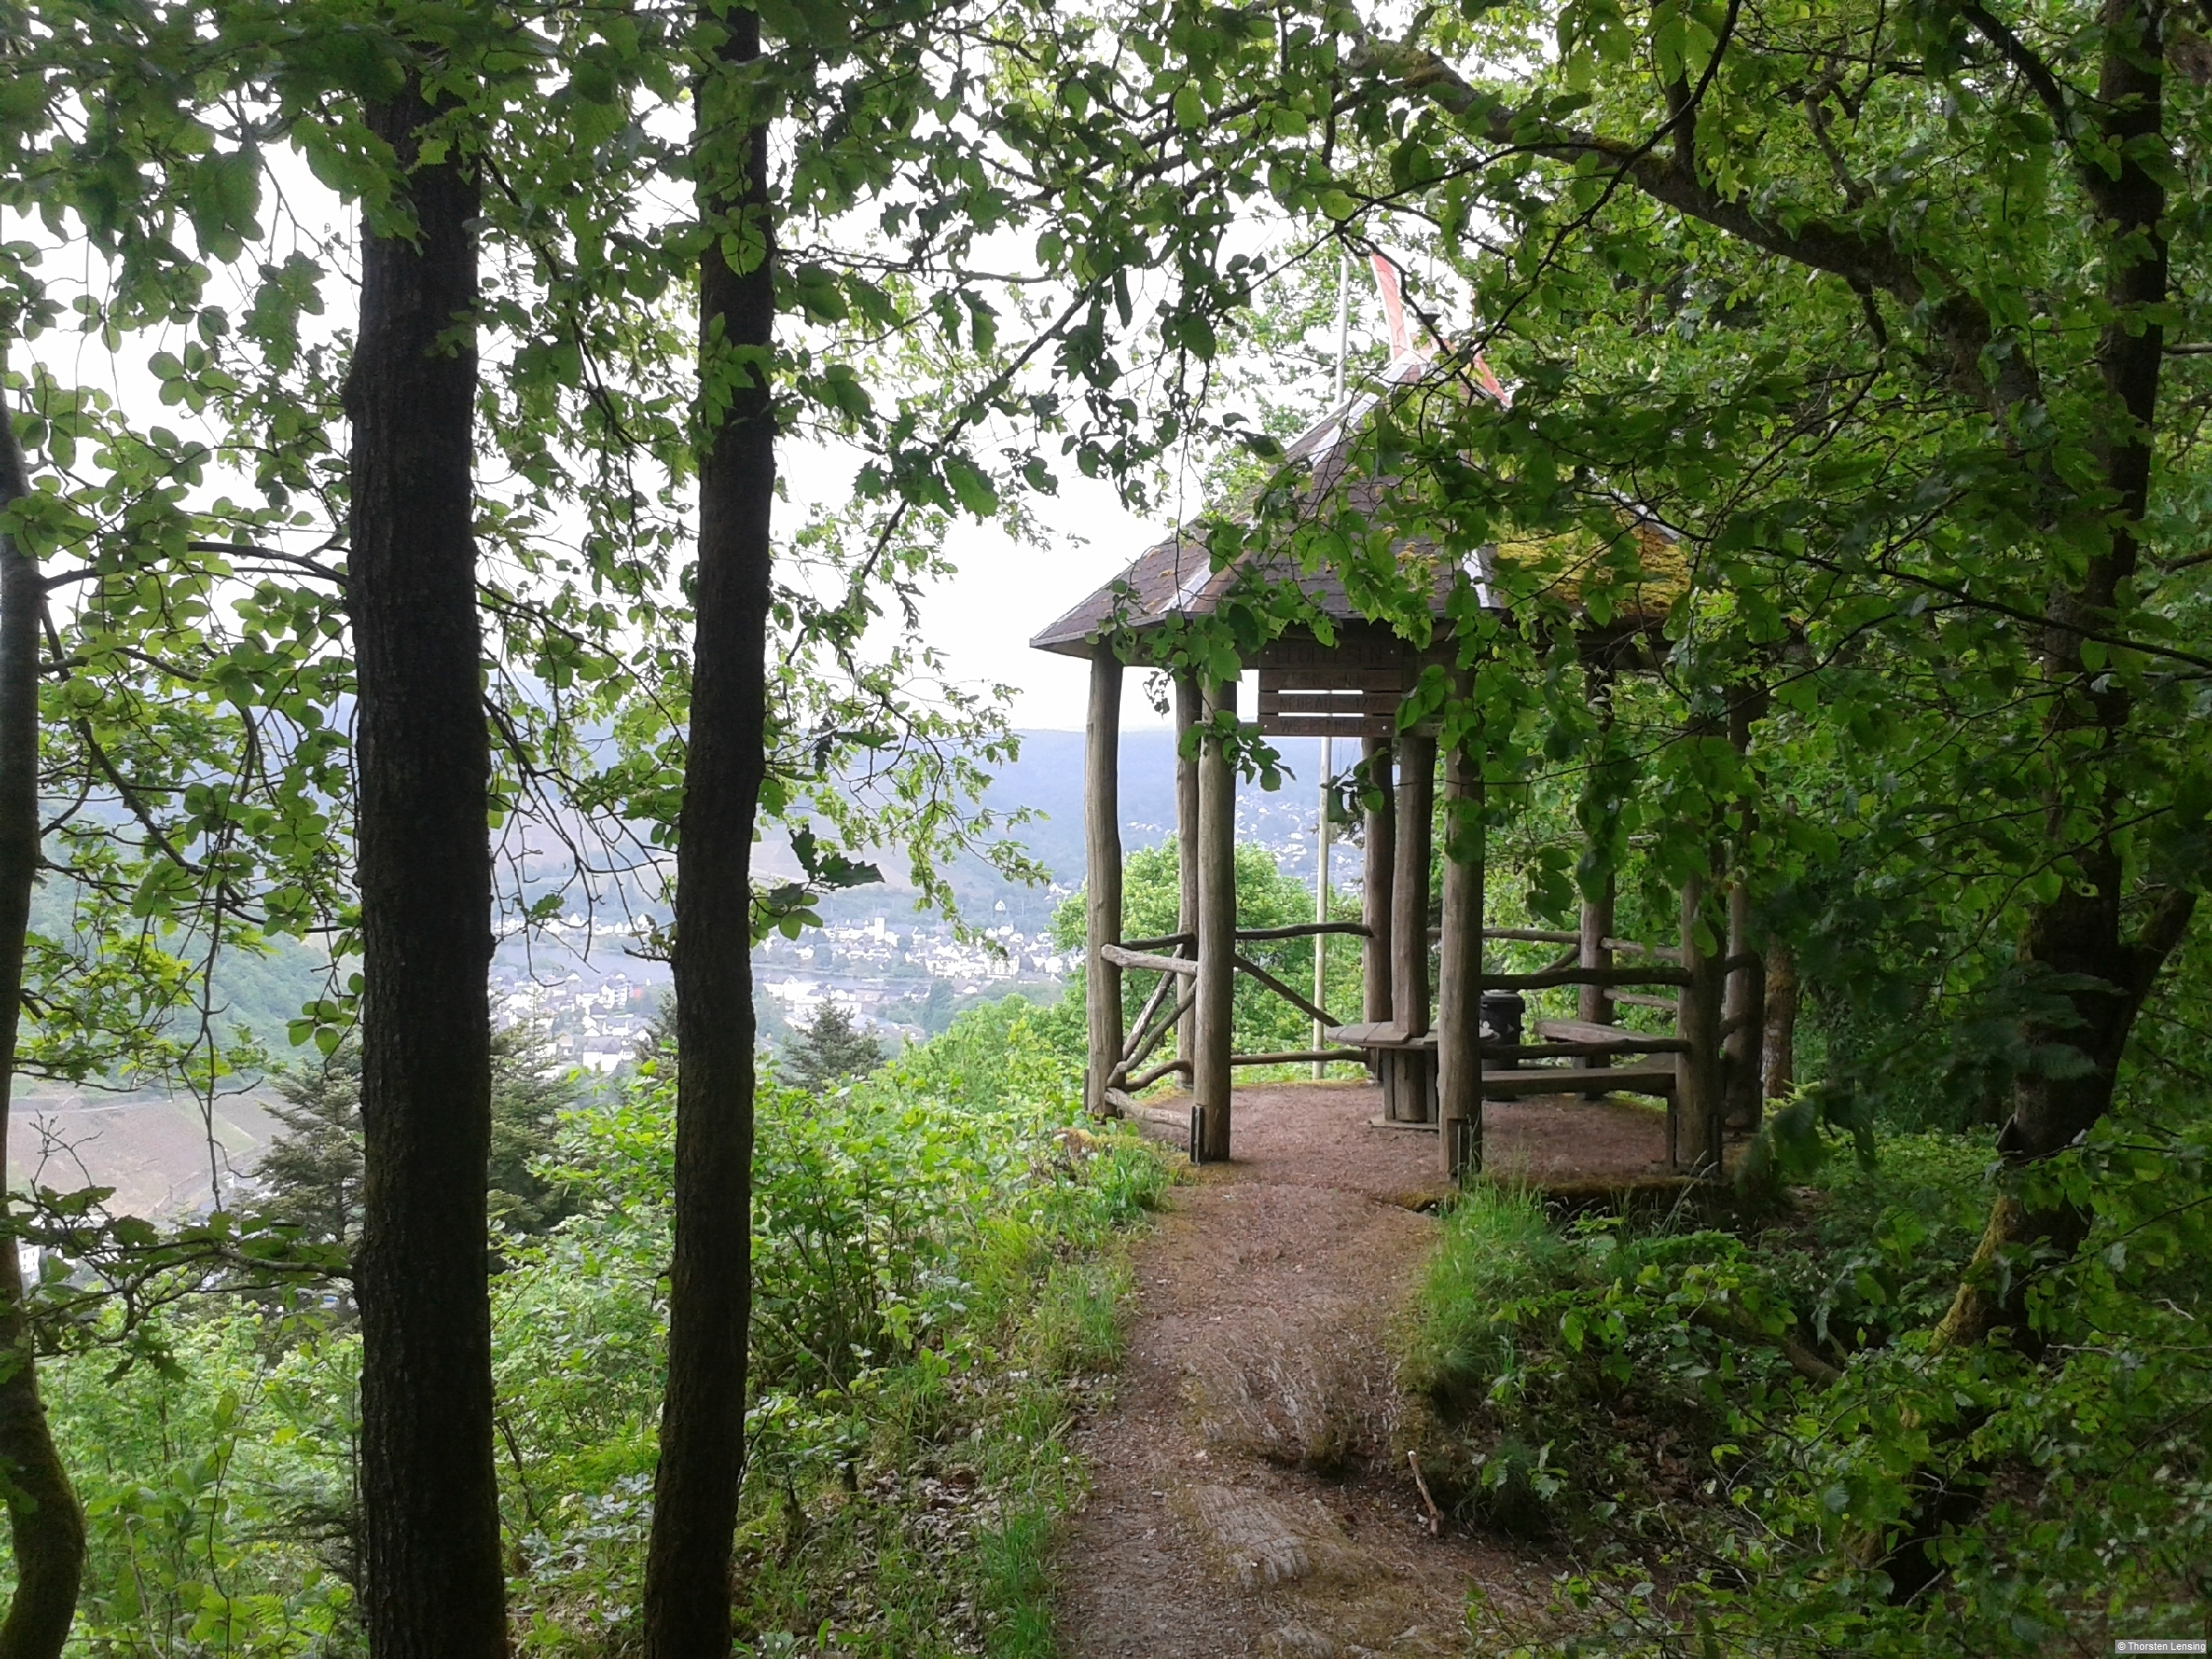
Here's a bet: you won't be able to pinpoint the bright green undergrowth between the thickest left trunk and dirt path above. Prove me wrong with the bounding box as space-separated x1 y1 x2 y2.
498 997 1163 1654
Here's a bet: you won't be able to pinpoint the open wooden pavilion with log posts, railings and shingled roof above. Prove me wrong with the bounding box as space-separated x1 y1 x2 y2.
1030 356 1763 1179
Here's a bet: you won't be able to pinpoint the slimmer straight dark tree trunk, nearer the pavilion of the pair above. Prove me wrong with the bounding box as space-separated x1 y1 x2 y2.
646 11 776 1659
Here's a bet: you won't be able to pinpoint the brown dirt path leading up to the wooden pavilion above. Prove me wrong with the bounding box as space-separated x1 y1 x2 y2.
1057 1084 1659 1659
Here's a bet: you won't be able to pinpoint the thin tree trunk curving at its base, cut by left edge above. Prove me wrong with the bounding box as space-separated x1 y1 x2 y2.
0 369 84 1659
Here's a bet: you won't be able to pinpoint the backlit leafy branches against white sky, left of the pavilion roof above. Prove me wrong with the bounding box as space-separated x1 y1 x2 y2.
0 5 1314 1132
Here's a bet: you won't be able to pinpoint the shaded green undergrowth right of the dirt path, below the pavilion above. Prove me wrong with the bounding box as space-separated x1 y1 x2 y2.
1406 1117 2212 1659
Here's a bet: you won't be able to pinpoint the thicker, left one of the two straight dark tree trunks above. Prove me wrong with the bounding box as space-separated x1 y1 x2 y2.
345 82 507 1659
